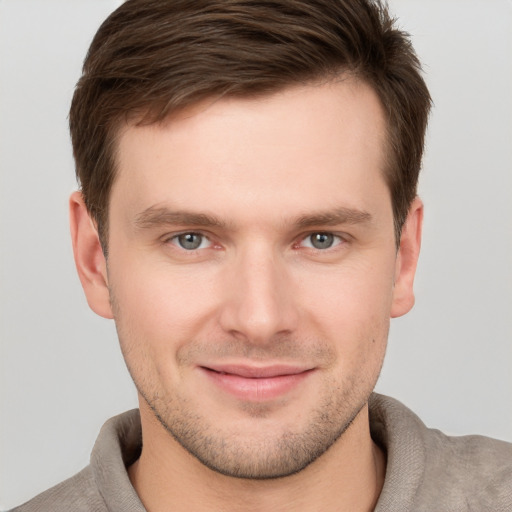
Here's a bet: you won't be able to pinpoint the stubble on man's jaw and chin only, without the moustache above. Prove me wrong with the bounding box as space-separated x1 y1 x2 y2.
123 340 378 480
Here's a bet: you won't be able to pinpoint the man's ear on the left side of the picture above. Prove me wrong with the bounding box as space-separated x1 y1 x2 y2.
69 192 113 318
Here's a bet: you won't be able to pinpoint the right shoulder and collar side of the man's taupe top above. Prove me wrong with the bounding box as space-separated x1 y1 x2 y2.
370 394 512 512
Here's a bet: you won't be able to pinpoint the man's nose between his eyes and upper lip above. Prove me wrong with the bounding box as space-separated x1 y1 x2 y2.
220 250 299 344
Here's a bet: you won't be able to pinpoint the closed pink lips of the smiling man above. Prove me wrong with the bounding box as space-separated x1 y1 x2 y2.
200 364 313 401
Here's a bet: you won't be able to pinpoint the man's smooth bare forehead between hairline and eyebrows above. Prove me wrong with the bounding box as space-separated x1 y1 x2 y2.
112 79 386 222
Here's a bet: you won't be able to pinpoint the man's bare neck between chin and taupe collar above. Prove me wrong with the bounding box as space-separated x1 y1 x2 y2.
128 401 385 512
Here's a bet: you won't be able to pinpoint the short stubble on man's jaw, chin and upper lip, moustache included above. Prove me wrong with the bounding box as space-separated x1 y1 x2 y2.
111 290 385 480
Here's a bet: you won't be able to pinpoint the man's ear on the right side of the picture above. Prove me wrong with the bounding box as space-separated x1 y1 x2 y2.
391 197 423 318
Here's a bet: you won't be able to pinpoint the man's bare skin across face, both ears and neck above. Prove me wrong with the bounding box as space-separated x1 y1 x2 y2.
70 79 423 512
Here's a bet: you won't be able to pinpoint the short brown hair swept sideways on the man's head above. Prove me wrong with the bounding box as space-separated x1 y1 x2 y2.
69 0 431 251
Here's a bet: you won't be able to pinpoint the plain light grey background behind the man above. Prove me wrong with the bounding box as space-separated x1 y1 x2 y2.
0 0 512 509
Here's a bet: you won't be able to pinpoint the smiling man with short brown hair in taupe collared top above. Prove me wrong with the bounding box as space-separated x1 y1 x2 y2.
11 0 512 511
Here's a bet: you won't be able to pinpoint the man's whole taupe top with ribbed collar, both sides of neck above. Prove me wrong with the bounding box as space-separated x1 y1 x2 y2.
12 394 512 512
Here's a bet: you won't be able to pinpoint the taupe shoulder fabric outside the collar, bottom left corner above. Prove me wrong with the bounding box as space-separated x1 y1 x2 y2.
11 466 108 512
